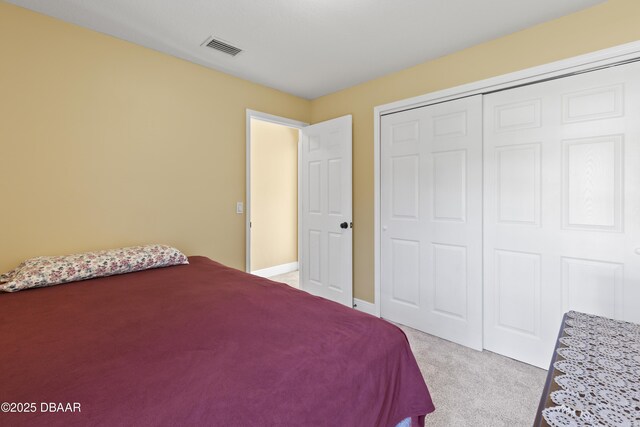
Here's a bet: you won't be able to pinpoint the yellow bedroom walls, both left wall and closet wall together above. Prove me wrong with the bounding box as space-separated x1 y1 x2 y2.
0 0 640 426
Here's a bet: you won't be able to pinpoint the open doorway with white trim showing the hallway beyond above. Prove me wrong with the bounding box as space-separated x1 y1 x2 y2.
246 111 304 287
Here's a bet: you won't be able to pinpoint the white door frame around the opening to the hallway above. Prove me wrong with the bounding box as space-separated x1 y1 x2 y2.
244 108 309 273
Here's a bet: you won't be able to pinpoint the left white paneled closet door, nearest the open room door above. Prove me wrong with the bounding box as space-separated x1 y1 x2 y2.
381 96 482 350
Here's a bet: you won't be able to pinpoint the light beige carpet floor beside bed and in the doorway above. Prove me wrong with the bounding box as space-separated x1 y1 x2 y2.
270 272 547 427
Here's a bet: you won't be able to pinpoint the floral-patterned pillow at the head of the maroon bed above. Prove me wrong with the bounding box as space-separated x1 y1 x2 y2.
0 245 189 292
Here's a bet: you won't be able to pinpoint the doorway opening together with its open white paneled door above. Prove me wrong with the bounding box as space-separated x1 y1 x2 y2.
245 110 353 307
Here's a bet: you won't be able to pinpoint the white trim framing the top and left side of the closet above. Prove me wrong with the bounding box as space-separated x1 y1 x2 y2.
373 41 640 317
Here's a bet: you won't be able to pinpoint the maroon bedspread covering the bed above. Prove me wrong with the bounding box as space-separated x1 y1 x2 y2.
0 257 434 427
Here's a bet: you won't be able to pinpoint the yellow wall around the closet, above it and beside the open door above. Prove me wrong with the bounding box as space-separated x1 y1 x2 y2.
311 0 640 302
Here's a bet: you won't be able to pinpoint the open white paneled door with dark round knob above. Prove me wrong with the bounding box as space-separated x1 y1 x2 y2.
299 115 353 307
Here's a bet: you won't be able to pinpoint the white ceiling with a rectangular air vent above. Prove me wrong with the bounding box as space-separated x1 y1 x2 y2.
8 0 604 99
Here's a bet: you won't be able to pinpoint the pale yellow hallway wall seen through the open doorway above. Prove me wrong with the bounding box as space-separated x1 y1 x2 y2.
251 119 298 271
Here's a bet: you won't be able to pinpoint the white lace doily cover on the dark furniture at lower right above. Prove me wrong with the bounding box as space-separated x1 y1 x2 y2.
542 311 640 427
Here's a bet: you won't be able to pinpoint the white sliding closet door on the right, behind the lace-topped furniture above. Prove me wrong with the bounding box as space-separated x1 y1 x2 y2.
484 64 640 368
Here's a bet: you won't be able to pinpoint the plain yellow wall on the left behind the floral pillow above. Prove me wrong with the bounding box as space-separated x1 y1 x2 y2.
0 2 310 272
